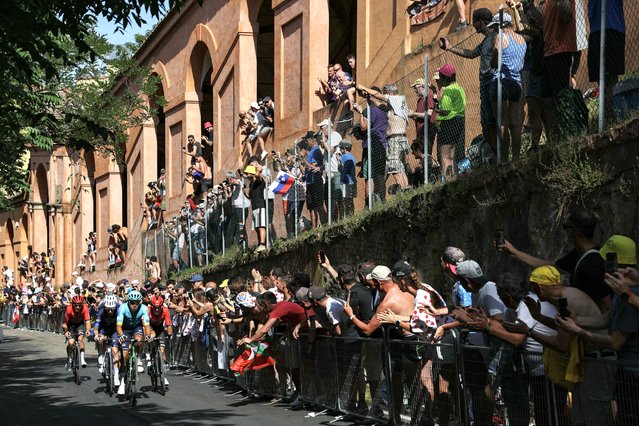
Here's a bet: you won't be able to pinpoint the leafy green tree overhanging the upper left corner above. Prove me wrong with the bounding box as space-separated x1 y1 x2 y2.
0 0 190 209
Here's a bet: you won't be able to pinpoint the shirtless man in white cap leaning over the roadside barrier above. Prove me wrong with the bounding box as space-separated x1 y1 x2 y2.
344 265 414 424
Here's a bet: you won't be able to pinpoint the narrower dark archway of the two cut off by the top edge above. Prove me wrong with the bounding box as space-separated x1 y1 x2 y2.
255 0 275 99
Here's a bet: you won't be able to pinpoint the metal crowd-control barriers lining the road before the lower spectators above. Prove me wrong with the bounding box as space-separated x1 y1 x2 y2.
0 304 639 426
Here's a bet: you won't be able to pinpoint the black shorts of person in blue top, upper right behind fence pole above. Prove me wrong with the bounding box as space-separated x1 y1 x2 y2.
588 30 626 81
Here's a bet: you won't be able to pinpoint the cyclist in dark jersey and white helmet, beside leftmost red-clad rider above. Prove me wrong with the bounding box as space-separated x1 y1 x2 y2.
93 294 120 386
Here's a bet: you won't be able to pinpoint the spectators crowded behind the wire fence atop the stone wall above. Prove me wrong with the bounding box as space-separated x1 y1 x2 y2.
131 0 639 286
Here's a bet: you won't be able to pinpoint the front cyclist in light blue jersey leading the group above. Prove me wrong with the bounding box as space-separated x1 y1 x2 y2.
115 290 151 395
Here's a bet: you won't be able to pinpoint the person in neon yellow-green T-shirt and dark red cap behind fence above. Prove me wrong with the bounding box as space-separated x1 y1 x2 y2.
435 64 466 178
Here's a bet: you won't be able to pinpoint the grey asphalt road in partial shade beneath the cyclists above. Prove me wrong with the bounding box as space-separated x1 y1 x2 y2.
0 327 346 426
